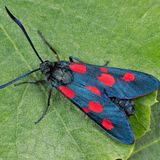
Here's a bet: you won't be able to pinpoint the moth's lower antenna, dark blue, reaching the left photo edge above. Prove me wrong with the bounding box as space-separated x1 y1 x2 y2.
0 68 40 89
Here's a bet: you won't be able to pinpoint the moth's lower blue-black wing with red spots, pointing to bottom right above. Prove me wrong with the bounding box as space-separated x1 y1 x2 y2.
59 80 134 144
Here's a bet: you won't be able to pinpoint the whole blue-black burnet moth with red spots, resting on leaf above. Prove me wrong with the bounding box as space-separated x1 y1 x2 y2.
0 7 160 144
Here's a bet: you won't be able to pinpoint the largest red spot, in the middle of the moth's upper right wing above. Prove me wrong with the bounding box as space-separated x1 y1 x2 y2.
98 73 116 87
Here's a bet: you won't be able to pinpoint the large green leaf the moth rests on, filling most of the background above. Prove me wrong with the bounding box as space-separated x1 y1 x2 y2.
0 0 160 160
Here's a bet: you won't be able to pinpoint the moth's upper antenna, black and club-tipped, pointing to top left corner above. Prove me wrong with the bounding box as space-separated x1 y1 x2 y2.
5 7 43 63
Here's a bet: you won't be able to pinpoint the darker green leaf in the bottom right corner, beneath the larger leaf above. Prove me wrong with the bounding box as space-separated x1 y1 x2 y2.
129 96 160 160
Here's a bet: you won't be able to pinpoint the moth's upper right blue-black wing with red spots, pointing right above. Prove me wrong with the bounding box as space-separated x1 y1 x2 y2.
69 63 160 99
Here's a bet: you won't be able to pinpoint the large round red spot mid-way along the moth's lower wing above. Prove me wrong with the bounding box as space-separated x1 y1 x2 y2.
88 101 103 113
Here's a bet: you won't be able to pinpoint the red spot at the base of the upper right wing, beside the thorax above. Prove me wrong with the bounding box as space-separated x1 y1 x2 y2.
69 63 87 74
